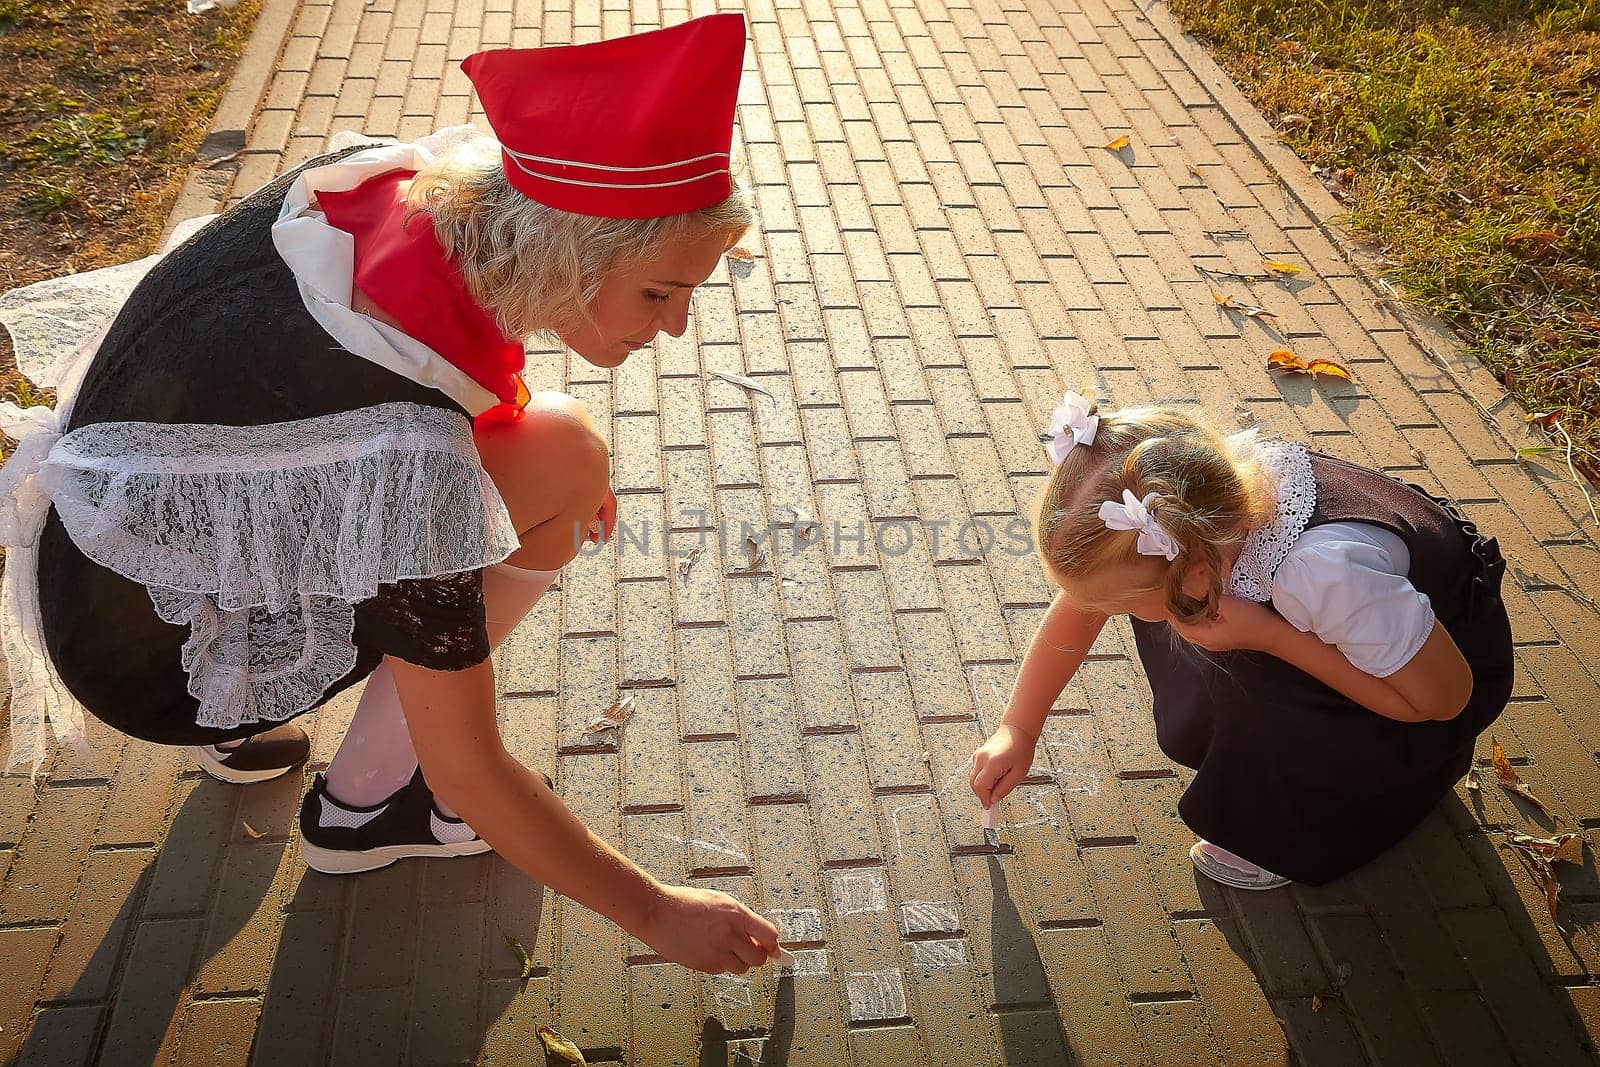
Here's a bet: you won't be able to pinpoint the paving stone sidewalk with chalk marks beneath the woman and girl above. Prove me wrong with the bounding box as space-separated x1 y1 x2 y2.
0 0 1600 1067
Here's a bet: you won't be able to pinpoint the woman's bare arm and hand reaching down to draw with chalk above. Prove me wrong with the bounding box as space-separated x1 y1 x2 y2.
387 657 778 973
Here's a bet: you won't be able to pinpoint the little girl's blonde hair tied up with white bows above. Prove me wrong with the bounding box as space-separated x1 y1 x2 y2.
1035 405 1275 622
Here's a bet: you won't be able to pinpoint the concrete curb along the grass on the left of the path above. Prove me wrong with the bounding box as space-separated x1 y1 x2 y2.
162 0 299 242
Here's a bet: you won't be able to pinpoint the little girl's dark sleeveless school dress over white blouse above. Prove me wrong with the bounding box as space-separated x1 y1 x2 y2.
1133 453 1514 885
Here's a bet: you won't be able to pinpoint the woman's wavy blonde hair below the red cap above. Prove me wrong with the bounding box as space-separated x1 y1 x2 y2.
396 138 755 338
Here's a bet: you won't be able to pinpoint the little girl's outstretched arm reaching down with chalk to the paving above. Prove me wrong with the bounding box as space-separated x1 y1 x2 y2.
971 592 1106 808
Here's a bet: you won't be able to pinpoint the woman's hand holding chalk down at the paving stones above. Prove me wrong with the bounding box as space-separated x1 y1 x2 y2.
638 885 778 974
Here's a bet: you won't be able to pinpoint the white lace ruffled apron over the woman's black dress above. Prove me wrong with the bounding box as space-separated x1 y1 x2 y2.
5 403 518 777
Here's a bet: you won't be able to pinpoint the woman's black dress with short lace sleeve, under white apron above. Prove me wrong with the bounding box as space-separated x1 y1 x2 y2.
21 149 507 744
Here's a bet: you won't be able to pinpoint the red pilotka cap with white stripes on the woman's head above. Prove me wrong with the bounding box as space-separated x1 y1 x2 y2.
461 14 744 219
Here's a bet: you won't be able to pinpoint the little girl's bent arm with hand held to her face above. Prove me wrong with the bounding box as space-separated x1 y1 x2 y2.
1171 597 1472 723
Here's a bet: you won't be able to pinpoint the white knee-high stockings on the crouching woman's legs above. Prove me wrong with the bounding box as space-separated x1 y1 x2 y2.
328 563 560 817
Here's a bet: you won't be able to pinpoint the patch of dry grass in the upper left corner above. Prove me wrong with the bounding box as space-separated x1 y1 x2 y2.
0 0 259 402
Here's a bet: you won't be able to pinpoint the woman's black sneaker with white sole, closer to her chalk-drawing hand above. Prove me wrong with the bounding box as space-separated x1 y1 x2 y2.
301 768 490 875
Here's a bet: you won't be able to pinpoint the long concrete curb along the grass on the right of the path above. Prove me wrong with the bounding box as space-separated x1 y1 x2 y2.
1144 0 1530 453
